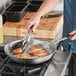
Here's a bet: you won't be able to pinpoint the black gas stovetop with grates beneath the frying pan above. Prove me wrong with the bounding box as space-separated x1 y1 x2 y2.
0 46 51 76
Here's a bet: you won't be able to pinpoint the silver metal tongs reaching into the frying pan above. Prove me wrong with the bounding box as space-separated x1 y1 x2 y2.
13 26 33 55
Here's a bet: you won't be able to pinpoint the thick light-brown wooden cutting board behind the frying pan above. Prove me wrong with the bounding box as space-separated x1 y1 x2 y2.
4 12 63 39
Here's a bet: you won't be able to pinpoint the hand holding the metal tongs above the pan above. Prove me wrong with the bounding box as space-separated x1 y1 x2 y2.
27 15 40 31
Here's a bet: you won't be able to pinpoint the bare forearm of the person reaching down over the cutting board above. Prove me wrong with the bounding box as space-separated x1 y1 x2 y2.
37 0 59 17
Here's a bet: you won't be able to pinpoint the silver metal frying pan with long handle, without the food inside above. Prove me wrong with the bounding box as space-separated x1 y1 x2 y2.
4 36 70 64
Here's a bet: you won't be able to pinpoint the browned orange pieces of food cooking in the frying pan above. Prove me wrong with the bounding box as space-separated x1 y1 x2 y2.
13 46 48 59
